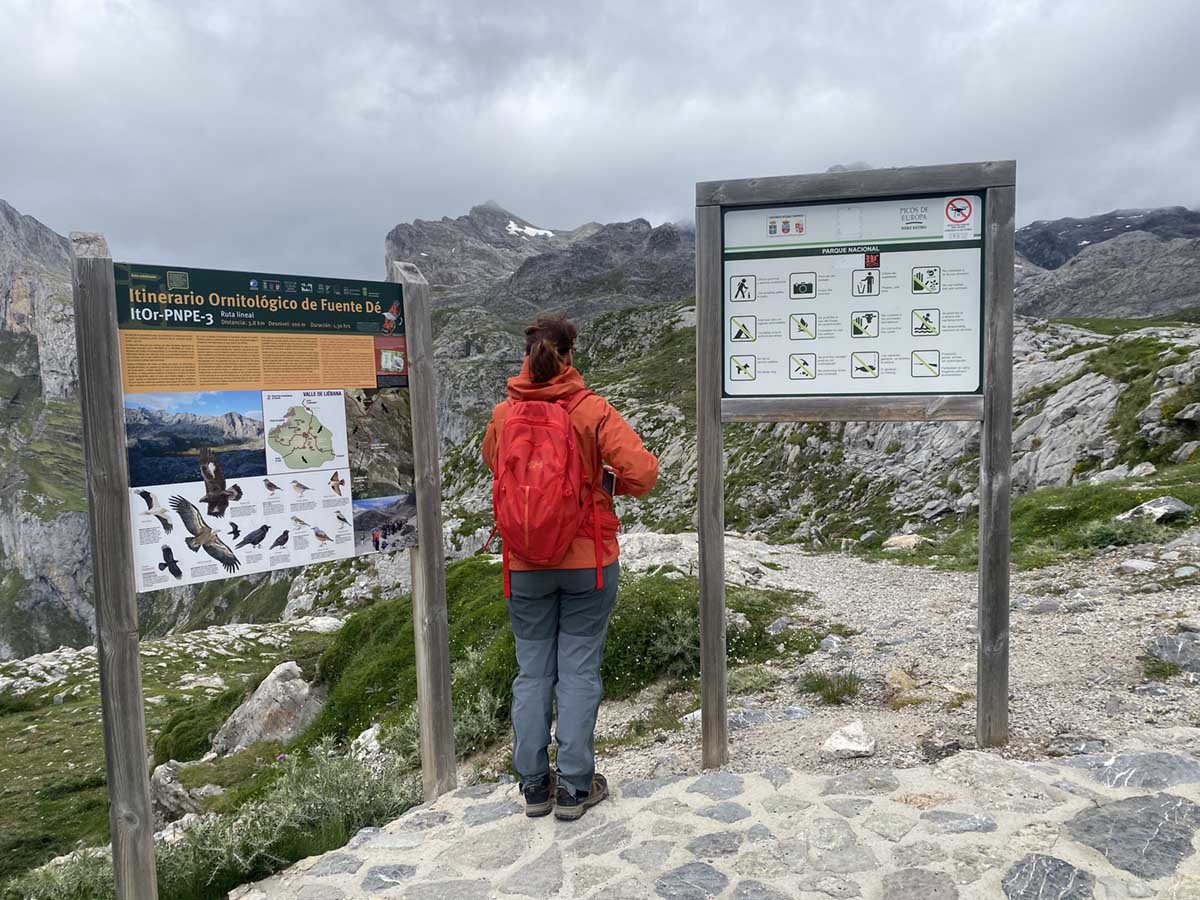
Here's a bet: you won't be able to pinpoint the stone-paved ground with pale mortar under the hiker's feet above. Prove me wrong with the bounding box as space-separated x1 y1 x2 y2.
230 744 1200 900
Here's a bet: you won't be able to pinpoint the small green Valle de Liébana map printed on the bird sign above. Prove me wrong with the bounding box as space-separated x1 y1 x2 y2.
263 390 347 474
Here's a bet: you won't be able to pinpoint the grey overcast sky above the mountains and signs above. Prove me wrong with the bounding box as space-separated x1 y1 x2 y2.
0 0 1200 278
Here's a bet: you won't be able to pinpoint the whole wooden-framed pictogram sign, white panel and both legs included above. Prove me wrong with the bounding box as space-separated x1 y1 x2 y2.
696 161 1016 768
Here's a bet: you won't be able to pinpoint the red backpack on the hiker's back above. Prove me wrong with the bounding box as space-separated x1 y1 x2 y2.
490 390 604 596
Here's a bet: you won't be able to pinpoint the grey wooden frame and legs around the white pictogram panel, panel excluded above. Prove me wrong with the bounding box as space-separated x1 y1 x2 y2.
696 161 1016 768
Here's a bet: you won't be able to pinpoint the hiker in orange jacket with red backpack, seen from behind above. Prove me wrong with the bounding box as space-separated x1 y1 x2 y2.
484 316 659 818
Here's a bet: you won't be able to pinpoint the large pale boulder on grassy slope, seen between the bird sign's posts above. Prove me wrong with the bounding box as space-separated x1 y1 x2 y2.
212 661 325 755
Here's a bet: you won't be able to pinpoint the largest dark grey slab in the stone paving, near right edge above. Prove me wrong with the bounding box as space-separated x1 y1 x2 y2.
1067 793 1200 878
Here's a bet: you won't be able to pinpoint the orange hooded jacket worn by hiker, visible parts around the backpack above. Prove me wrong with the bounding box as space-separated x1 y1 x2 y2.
484 356 659 571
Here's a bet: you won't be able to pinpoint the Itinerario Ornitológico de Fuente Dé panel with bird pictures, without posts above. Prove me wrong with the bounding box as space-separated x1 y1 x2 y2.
114 263 416 590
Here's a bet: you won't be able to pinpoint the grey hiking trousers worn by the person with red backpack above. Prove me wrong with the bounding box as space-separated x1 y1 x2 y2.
509 563 620 797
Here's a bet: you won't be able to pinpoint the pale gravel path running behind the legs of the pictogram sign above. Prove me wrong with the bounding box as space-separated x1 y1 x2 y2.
600 532 1200 776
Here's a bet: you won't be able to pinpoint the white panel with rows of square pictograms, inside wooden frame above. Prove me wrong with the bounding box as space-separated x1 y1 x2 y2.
724 194 983 397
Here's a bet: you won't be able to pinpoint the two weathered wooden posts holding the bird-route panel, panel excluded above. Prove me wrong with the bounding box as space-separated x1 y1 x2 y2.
71 232 457 900
